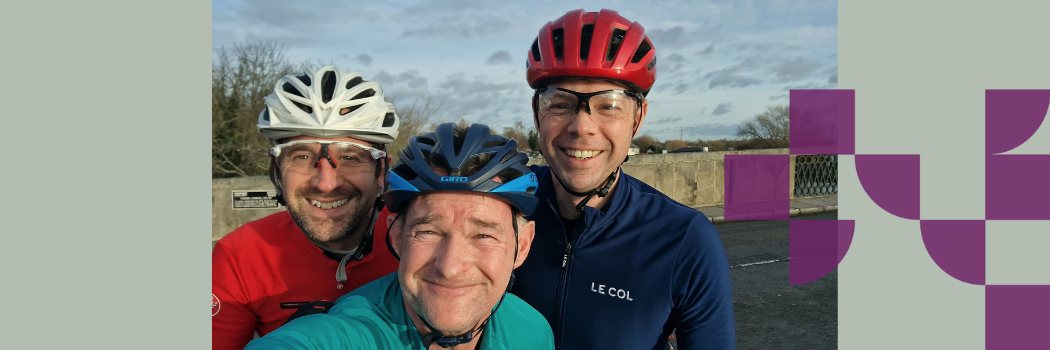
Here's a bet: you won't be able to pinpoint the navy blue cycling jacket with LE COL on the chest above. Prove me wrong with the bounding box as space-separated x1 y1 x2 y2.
511 166 736 350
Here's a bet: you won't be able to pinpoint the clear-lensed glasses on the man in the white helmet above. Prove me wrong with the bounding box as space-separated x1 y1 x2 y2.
270 140 386 174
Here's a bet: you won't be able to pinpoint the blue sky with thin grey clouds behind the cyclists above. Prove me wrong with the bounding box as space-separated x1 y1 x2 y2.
212 0 838 141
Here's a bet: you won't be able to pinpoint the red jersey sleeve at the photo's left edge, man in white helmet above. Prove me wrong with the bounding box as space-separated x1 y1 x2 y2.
211 242 258 350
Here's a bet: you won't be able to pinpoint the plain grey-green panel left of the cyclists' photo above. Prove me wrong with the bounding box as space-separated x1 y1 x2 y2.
0 0 211 349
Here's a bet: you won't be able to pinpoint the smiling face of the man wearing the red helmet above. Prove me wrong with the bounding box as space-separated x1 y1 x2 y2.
537 79 649 192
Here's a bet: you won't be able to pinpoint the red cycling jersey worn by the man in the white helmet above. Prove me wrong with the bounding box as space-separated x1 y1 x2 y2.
211 209 398 350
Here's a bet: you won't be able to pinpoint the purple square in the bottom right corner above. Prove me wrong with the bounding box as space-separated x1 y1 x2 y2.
985 286 1050 350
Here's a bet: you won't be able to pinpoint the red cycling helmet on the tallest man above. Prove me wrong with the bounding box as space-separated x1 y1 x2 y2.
526 8 656 95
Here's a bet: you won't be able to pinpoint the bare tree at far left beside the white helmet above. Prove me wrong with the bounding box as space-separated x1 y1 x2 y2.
211 41 295 178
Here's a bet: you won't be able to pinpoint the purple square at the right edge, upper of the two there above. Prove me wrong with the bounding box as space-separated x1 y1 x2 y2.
985 155 1050 220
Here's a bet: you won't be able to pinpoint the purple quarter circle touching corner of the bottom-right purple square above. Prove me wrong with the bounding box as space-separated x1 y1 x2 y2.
919 220 985 285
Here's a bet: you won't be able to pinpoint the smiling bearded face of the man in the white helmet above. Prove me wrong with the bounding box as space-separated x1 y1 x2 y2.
280 136 385 244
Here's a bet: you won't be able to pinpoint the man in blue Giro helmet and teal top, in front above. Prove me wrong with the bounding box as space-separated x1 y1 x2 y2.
248 123 553 349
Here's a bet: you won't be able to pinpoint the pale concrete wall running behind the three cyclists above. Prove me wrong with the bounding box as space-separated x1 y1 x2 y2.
211 148 795 242
